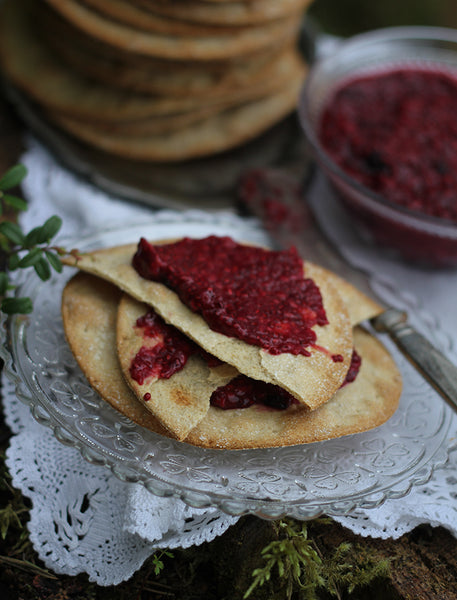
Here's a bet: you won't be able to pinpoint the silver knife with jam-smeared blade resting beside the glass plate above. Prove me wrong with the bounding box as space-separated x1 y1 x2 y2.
238 169 457 411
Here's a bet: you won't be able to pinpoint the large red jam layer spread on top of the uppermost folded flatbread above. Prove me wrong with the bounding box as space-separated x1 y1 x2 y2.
133 236 327 356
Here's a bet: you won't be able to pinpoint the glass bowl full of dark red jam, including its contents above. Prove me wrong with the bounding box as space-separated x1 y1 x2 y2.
299 27 457 267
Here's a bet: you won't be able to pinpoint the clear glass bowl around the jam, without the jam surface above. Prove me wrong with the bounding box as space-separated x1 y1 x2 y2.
298 27 457 267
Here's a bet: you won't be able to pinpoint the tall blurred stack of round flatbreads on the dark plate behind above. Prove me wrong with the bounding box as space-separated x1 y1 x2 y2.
0 0 311 163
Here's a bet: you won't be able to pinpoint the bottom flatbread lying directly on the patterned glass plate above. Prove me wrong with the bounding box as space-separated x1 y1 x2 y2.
62 273 401 449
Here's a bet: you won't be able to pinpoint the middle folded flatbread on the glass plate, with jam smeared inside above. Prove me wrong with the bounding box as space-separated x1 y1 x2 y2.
116 294 238 440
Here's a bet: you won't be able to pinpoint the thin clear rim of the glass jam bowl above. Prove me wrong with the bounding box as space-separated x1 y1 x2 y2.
297 25 457 235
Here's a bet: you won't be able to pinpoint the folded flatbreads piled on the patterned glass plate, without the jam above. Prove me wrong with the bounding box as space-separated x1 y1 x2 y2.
62 237 401 449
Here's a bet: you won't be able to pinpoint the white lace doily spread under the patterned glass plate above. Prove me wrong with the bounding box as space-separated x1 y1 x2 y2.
3 140 457 585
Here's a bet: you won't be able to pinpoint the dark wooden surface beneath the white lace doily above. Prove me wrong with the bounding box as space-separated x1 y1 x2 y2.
0 86 457 600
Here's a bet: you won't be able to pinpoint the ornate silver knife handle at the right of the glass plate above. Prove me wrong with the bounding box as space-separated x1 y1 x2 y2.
371 308 457 411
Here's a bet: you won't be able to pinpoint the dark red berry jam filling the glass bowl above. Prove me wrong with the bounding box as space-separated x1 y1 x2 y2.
319 68 457 222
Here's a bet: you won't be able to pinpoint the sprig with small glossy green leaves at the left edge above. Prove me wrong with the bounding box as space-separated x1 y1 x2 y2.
0 165 67 314
